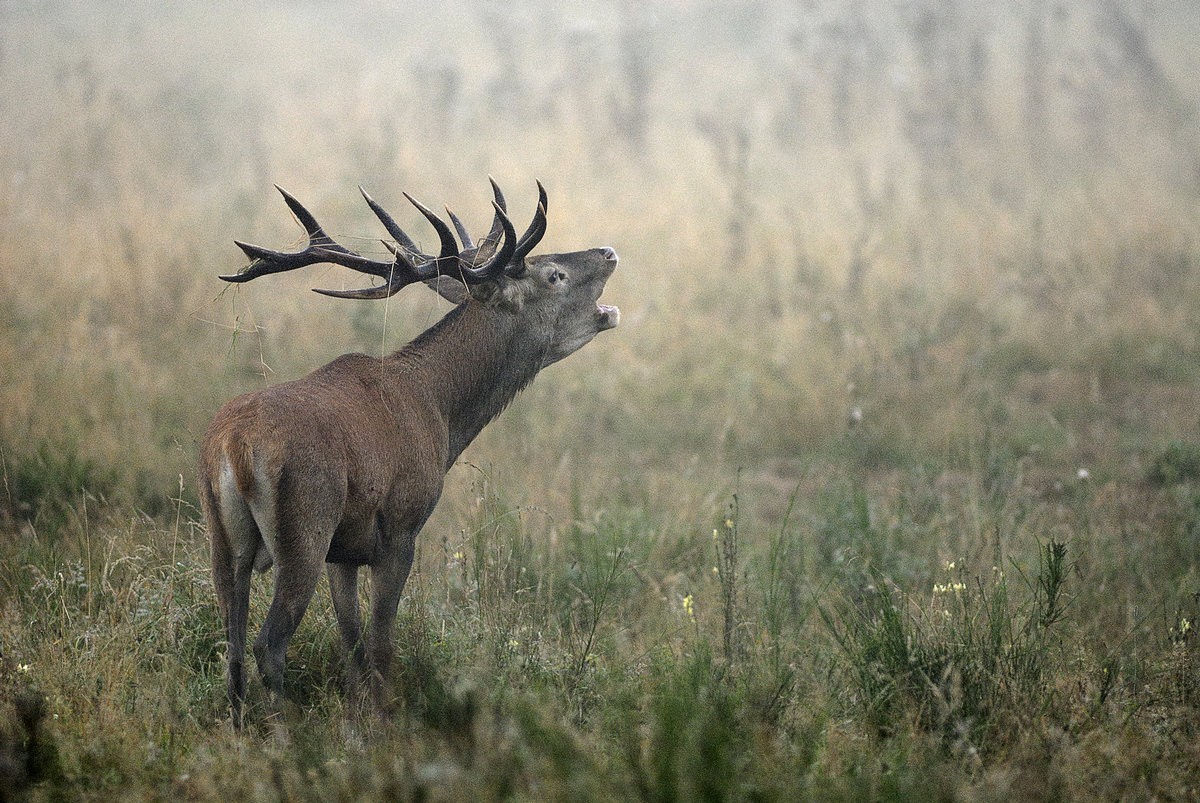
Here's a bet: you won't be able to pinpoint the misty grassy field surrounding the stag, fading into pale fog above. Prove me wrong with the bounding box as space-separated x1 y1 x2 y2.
0 0 1200 801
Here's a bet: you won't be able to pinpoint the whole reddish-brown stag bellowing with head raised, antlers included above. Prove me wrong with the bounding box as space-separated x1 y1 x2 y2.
200 181 620 726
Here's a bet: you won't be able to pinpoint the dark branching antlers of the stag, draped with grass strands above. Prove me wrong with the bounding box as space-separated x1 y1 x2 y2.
221 180 546 299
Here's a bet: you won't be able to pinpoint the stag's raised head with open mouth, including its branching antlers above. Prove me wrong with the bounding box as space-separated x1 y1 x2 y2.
221 181 620 365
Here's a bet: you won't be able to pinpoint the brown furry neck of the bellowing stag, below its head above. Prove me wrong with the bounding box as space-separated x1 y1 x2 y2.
388 300 542 468
